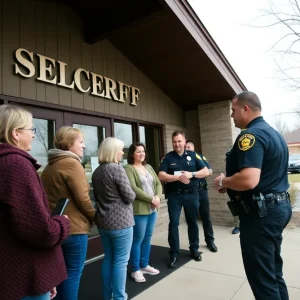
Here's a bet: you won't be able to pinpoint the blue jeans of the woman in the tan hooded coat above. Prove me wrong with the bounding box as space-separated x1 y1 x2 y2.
55 234 88 300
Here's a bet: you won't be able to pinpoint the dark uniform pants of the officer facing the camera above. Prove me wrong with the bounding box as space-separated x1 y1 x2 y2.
168 191 199 257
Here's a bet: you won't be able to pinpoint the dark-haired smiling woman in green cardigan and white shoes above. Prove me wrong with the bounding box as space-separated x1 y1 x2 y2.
125 143 162 282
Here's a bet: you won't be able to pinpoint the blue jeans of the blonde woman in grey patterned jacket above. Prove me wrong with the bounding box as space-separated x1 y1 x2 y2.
99 227 133 300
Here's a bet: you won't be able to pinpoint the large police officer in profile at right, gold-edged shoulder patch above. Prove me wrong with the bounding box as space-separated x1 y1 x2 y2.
214 92 291 300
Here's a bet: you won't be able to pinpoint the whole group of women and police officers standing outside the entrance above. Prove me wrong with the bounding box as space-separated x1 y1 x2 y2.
0 92 291 300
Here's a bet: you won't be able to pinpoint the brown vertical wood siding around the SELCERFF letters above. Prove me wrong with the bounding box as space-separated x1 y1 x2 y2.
0 0 185 126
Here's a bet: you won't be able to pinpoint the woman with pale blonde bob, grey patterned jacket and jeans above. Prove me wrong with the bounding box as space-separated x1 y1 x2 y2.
92 137 135 300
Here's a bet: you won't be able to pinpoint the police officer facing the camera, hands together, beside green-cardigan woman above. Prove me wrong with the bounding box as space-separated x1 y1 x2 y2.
158 131 209 268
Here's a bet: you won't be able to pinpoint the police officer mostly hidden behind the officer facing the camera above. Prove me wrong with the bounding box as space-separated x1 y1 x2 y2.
185 140 218 252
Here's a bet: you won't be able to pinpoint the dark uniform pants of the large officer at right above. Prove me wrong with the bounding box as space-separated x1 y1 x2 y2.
240 200 292 300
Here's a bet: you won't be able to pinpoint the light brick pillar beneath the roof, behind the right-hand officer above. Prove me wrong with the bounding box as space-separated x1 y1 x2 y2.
198 101 239 226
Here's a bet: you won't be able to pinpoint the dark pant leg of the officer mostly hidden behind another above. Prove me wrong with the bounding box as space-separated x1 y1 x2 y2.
199 189 214 245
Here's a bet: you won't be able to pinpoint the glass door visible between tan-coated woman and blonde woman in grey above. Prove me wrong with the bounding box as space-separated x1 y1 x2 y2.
64 112 111 260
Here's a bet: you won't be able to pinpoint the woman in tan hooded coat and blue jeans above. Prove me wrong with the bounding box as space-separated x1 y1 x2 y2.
41 126 95 300
